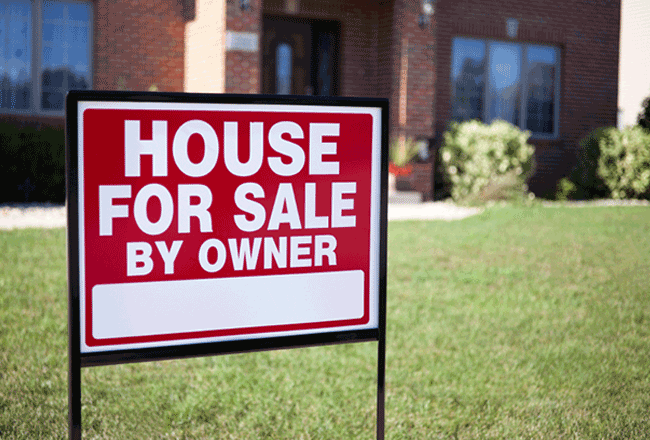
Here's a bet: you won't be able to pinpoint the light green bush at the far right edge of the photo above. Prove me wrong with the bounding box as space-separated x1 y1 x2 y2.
598 126 650 199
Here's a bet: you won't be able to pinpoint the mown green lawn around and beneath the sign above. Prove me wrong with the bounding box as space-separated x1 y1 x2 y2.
0 207 650 440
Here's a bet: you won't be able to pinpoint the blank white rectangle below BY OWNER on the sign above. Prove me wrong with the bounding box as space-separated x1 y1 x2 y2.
92 270 364 339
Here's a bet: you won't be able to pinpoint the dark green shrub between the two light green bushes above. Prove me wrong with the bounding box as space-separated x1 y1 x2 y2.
558 128 610 200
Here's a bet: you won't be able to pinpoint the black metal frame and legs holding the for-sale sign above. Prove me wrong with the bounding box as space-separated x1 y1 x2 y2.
65 91 389 440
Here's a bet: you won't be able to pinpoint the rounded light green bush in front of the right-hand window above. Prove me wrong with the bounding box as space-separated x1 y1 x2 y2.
441 121 535 203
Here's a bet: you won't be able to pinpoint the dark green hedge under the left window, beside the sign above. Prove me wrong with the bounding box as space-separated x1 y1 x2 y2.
0 122 65 203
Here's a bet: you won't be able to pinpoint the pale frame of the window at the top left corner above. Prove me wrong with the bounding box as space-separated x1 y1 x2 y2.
0 0 95 118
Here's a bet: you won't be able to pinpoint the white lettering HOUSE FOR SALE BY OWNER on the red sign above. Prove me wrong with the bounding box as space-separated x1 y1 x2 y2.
99 119 357 276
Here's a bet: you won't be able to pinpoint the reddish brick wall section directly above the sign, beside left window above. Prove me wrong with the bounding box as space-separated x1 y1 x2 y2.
93 0 185 92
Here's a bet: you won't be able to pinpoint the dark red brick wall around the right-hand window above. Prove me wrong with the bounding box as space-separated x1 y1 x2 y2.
435 0 620 193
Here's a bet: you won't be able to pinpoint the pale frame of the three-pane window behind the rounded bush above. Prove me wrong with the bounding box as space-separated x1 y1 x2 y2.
449 35 562 140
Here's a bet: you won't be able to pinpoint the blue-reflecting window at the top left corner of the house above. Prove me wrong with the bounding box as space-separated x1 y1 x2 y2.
0 0 92 114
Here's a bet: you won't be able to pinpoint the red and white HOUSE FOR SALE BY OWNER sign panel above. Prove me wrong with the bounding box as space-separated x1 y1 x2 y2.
77 101 381 353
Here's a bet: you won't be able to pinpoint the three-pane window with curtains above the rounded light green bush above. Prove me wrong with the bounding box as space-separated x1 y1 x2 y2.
451 38 559 137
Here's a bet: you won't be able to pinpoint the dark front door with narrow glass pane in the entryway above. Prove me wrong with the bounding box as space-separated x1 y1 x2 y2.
262 17 339 96
